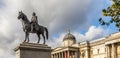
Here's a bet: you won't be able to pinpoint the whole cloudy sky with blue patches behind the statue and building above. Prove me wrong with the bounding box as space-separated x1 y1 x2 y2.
0 0 117 58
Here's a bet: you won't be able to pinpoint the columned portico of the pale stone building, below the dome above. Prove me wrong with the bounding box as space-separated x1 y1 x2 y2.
52 47 79 58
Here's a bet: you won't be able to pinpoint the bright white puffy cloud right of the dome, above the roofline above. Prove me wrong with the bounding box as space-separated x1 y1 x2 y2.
73 26 107 42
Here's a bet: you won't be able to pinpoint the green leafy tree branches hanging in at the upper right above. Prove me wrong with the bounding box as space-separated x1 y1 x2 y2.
99 0 120 31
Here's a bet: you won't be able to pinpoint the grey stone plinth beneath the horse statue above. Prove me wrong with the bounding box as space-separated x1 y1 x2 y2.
14 43 51 58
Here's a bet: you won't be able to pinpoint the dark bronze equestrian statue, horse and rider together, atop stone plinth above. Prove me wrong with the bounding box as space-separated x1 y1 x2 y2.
18 11 48 44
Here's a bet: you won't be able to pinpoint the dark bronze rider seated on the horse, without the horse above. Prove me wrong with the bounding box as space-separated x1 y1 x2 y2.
31 12 38 32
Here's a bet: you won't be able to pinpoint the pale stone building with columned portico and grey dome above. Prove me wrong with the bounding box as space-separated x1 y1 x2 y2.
51 32 120 58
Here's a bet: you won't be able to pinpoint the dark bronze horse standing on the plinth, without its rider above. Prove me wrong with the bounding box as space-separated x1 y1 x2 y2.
18 11 48 44
